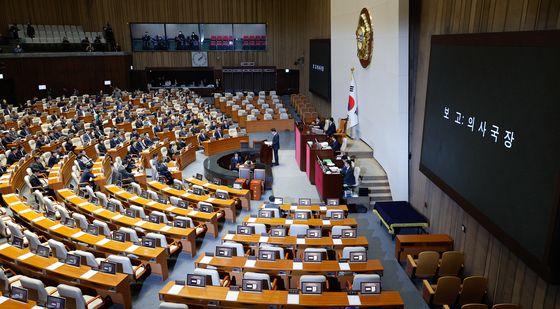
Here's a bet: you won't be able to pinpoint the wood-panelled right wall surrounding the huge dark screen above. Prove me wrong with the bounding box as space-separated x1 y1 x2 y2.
410 0 560 309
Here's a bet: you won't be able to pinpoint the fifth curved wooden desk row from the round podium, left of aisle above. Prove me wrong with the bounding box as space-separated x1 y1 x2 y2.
4 194 169 280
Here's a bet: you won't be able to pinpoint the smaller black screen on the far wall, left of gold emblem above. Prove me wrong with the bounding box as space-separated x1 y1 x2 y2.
309 39 331 100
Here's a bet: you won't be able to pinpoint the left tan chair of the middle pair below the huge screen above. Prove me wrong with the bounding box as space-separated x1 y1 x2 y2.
422 276 461 306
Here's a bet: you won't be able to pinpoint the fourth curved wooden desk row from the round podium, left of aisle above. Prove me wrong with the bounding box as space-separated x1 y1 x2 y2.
57 189 196 256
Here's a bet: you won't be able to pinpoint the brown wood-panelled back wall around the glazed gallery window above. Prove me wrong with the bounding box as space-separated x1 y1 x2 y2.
0 0 330 109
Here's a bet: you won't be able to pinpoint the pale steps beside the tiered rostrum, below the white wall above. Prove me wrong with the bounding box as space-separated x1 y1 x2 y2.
346 140 393 205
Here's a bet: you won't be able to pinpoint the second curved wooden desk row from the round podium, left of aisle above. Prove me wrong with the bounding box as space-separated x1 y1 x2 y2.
147 181 237 222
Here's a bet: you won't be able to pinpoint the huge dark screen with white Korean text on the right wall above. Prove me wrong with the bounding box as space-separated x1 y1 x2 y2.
420 31 560 275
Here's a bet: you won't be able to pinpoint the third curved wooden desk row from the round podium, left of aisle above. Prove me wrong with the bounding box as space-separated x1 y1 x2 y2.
105 185 218 238
